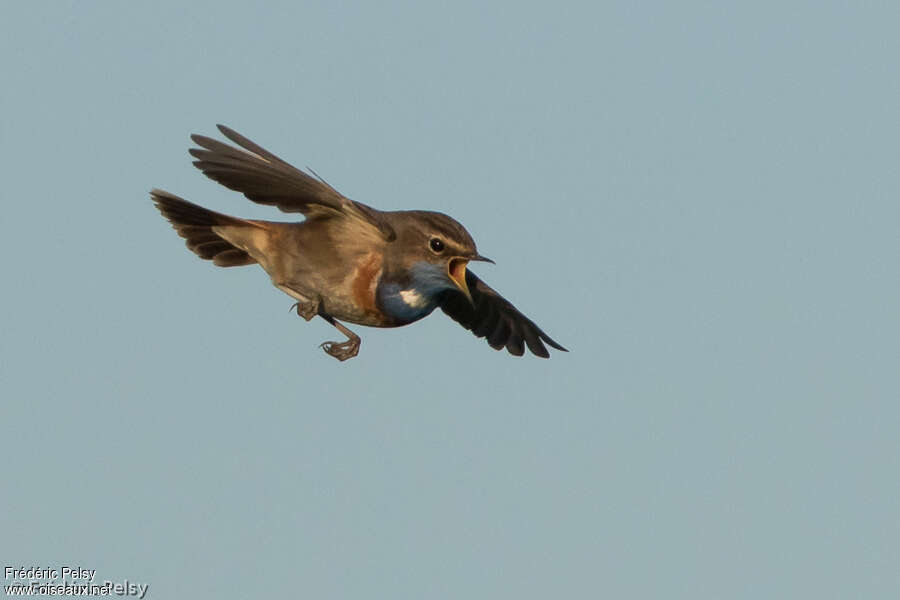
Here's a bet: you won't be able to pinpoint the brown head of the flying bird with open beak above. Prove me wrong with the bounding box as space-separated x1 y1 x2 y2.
387 211 494 302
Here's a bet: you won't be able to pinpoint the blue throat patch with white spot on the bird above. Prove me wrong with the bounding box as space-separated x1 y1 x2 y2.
375 262 456 323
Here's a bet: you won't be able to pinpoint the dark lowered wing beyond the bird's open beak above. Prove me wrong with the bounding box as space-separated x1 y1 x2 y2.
441 271 568 358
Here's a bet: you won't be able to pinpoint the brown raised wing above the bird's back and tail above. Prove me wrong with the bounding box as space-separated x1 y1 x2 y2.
190 125 394 239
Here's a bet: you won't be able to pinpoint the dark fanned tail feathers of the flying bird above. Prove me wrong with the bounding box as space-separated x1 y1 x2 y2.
150 190 256 267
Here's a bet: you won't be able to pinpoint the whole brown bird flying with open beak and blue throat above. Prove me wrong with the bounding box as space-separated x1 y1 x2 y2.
150 125 568 361
